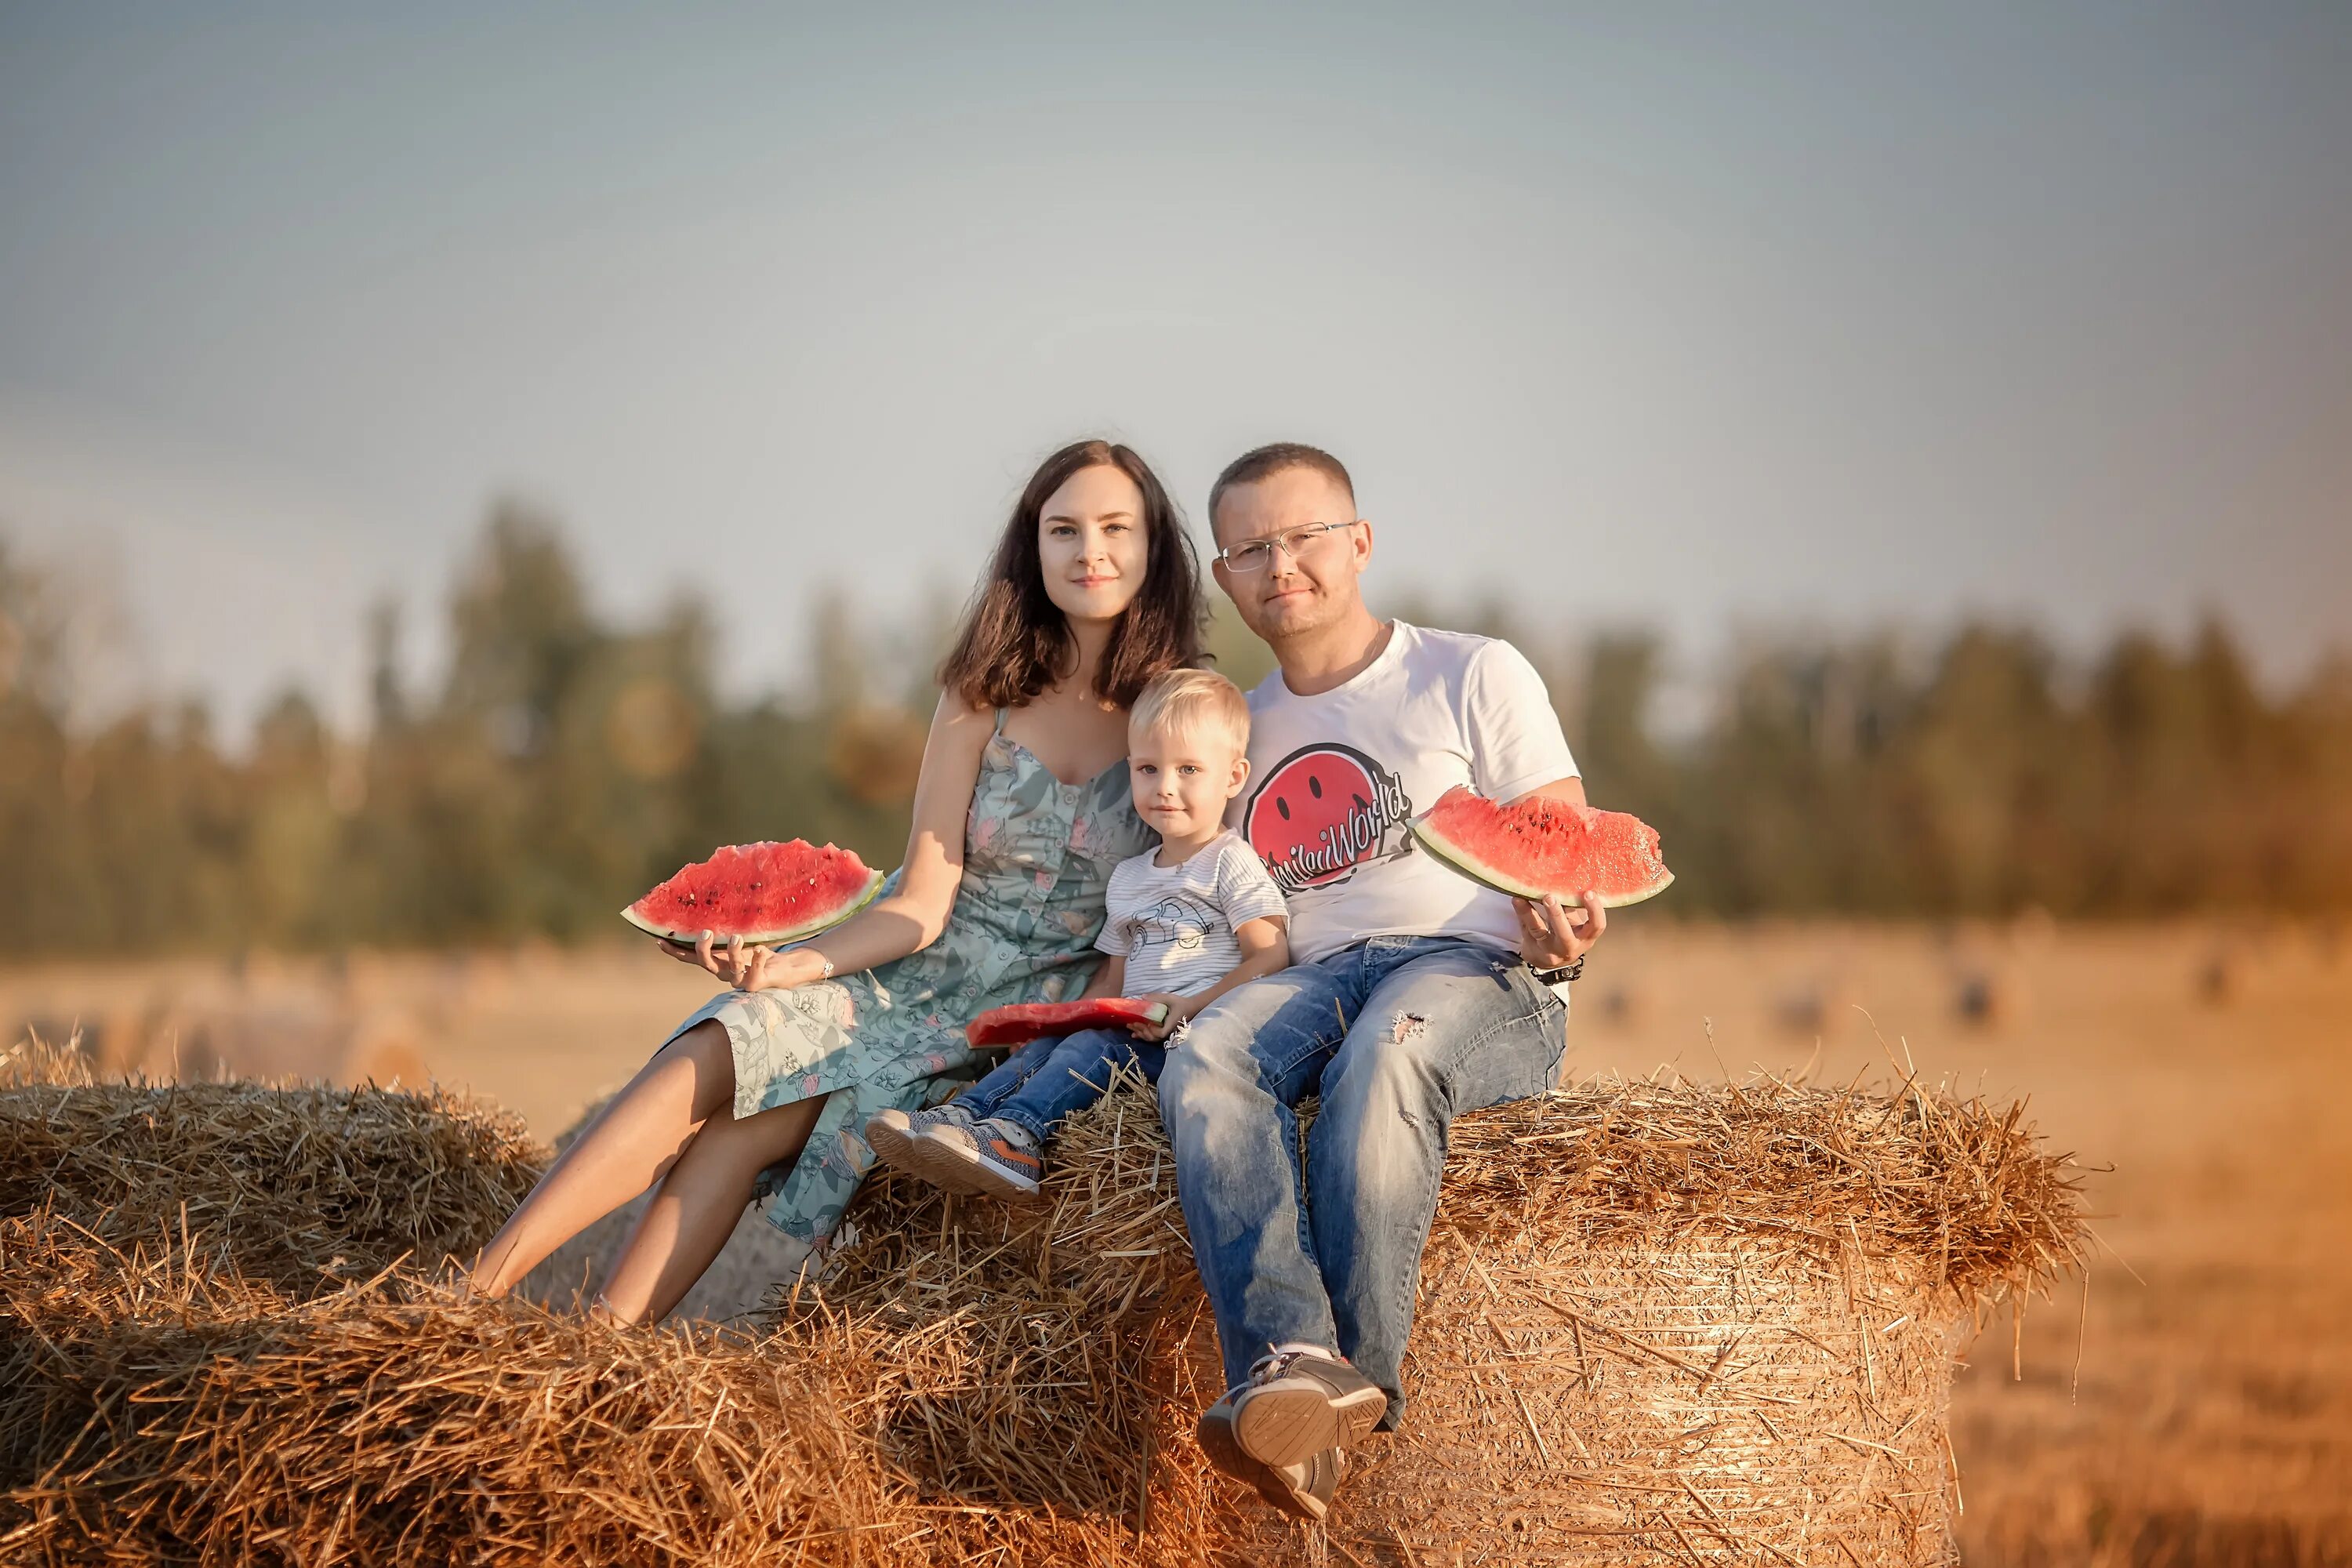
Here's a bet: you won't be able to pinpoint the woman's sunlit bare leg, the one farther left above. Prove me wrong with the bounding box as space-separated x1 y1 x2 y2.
470 1018 734 1295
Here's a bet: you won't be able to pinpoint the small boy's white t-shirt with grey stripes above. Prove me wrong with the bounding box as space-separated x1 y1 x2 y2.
1094 832 1284 996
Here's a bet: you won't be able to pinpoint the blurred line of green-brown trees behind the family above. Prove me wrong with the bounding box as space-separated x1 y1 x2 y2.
0 506 2352 954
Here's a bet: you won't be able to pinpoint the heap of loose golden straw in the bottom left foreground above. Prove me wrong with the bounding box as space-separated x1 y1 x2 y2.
0 1215 908 1568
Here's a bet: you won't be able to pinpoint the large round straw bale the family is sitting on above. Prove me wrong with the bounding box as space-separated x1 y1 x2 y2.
814 1079 2079 1563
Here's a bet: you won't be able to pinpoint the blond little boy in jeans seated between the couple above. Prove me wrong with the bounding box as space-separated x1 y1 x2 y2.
866 670 1291 1199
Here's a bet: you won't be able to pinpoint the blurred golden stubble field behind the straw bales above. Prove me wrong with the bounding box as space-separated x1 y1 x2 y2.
0 914 2352 1568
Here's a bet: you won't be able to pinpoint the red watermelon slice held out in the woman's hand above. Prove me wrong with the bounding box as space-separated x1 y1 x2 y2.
621 839 882 947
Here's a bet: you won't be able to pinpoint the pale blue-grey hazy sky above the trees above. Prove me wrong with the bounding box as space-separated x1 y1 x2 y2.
0 0 2352 738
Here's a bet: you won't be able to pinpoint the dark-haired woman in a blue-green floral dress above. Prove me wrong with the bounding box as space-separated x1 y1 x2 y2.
473 442 1202 1323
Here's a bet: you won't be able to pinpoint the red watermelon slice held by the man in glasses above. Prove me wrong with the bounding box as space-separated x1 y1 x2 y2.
1409 785 1675 909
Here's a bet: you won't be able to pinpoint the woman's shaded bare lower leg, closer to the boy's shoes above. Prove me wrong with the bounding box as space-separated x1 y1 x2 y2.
597 1095 826 1323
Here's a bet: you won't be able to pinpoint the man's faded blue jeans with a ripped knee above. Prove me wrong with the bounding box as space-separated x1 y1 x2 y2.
1160 935 1569 1427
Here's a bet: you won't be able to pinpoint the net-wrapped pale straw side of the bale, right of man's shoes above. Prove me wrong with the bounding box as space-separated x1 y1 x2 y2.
1289 1227 1959 1563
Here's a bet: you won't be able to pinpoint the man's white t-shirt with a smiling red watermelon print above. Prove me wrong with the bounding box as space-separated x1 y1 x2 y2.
1225 621 1576 964
